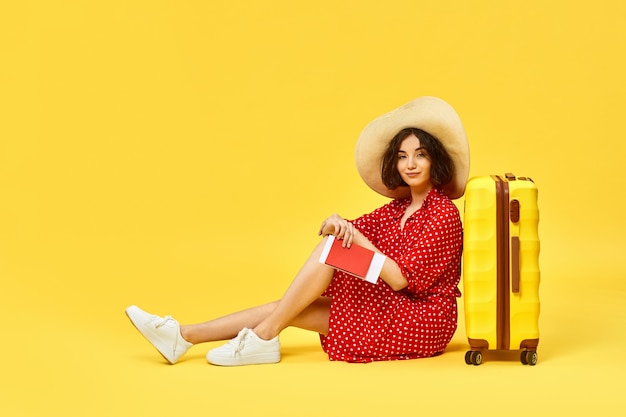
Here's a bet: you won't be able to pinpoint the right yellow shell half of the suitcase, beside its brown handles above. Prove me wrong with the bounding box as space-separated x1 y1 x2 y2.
509 180 540 349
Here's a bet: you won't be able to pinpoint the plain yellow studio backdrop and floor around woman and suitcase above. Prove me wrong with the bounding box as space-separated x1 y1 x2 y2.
0 0 626 416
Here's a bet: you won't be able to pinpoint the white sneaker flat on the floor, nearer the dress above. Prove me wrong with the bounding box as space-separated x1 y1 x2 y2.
206 328 280 366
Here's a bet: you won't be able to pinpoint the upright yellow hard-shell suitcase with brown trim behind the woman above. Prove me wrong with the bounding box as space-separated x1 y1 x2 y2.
463 174 540 365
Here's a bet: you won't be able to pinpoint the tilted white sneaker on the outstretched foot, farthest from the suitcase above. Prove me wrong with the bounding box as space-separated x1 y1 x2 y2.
126 306 193 364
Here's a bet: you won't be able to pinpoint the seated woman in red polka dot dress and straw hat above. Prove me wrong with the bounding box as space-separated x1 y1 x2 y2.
126 97 469 366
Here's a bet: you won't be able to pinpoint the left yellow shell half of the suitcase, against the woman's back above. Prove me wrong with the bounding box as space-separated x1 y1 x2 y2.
463 177 498 349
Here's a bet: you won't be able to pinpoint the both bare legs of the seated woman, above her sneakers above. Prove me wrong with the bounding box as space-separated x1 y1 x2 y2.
180 240 334 344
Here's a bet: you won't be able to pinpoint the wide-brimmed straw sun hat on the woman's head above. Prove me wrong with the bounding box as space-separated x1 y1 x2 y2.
355 96 469 199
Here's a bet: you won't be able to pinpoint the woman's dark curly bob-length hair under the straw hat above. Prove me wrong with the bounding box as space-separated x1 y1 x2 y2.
381 127 454 190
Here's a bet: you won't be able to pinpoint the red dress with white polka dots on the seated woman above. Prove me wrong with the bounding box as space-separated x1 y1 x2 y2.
321 189 463 362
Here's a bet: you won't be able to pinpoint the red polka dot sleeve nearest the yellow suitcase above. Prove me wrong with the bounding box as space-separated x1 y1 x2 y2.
396 205 463 294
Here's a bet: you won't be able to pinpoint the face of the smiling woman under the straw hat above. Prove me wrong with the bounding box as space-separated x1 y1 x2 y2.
398 135 432 190
